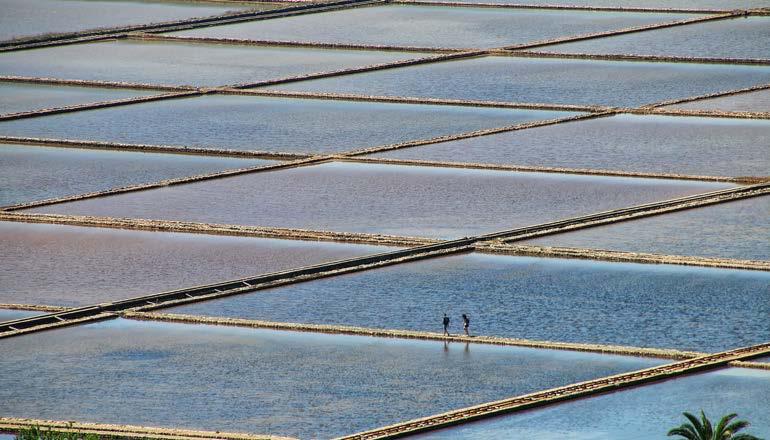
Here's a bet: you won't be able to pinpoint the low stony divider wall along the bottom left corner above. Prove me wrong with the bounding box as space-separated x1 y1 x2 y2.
0 417 294 440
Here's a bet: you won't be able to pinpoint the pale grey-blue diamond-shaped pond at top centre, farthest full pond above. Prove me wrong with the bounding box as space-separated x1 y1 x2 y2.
171 4 695 48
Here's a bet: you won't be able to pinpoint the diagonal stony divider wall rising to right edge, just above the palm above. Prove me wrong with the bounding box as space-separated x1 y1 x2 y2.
337 343 770 440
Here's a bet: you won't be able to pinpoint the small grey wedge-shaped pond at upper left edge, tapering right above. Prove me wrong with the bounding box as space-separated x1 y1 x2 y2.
0 82 162 114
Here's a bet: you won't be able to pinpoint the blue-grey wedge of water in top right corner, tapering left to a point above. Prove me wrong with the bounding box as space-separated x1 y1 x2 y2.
539 17 770 58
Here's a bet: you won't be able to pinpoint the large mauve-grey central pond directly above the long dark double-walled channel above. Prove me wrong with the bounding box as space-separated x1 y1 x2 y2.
25 162 729 238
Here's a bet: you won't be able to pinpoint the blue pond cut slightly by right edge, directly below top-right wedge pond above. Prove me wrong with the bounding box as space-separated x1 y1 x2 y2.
270 55 770 107
